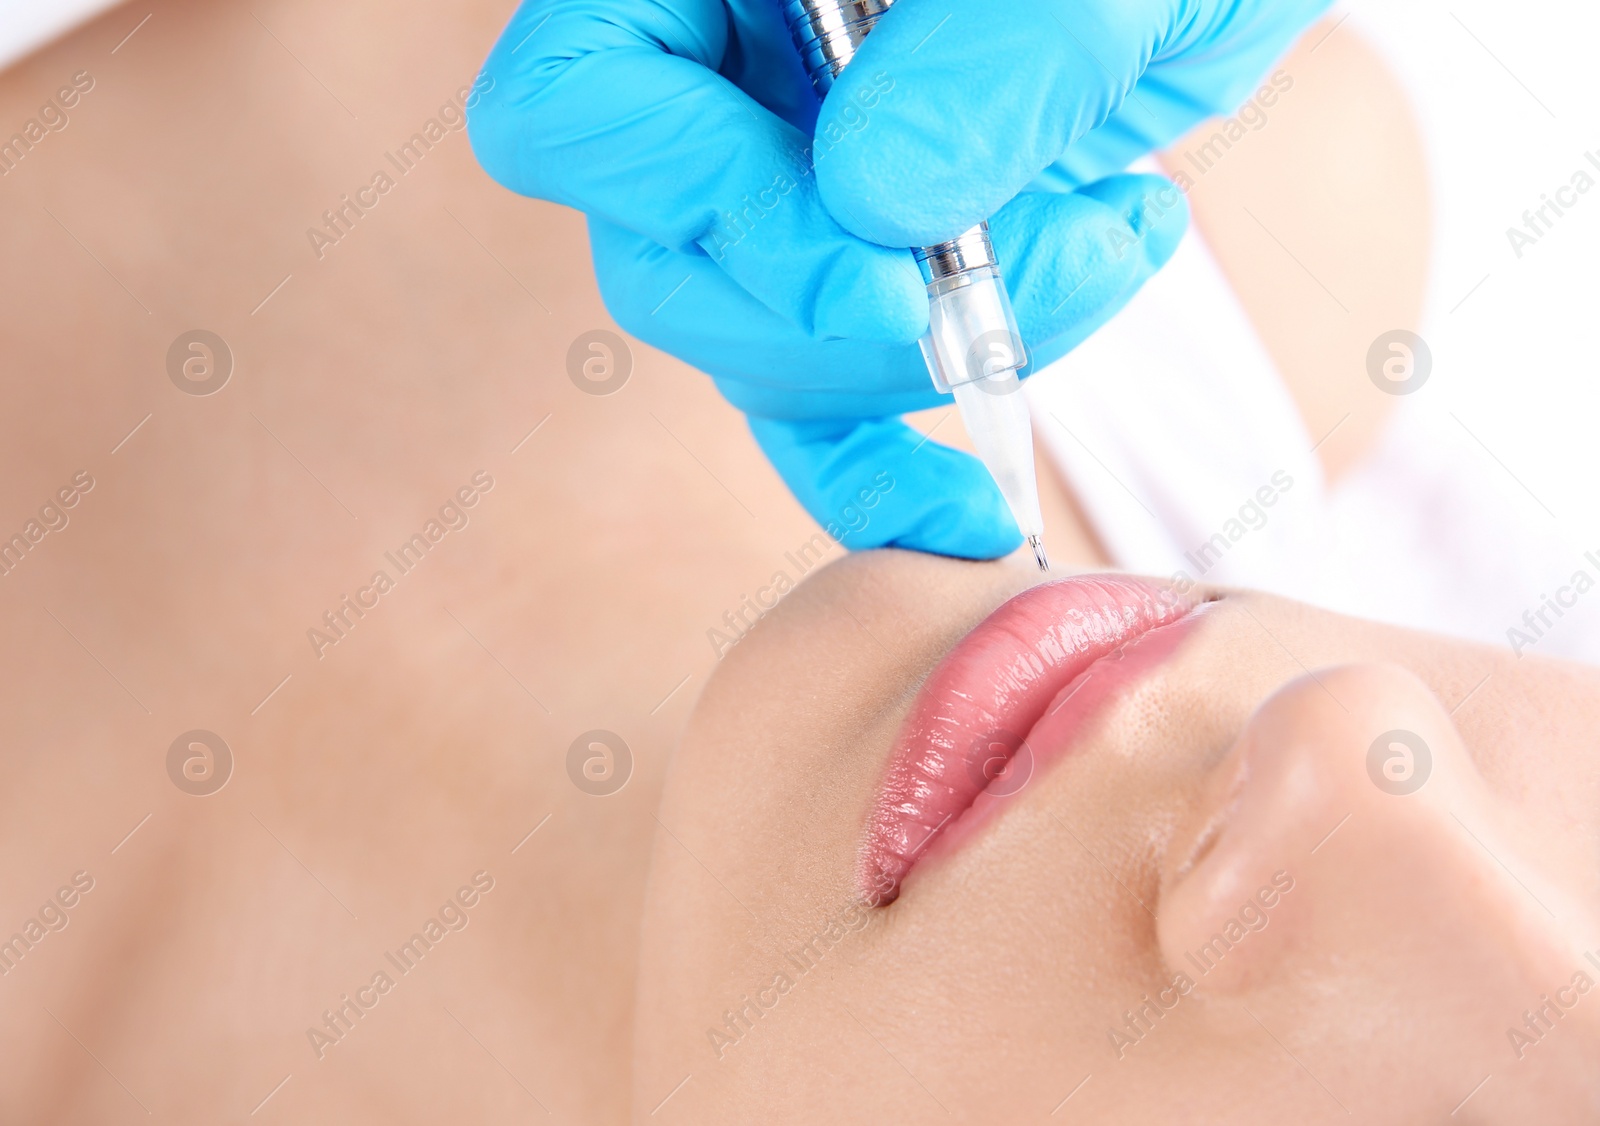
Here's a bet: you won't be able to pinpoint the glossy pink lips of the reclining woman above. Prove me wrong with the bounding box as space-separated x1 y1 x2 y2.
861 576 1198 905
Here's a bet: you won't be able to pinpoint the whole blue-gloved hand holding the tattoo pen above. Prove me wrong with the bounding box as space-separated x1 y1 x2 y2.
469 0 1330 558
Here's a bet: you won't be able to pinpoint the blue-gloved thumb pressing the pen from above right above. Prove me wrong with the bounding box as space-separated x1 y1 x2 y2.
818 0 1328 246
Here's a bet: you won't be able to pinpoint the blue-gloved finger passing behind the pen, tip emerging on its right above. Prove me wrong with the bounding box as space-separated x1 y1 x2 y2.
589 176 1187 419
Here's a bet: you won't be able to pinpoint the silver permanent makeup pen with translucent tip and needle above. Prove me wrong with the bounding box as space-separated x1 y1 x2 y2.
784 0 1050 571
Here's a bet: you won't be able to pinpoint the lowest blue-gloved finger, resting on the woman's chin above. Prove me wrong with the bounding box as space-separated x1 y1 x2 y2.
750 417 1022 560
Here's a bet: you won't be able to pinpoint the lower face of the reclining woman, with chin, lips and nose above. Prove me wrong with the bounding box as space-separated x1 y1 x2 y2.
634 552 1600 1123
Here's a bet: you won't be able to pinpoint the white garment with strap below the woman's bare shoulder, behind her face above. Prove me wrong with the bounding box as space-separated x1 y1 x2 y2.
1027 222 1600 662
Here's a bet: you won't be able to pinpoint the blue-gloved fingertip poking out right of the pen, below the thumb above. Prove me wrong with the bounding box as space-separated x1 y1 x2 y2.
989 174 1189 371
